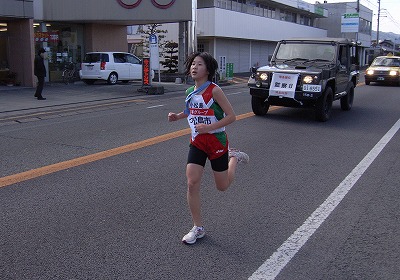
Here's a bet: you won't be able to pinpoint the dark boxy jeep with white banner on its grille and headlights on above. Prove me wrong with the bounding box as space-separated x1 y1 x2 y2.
248 38 359 122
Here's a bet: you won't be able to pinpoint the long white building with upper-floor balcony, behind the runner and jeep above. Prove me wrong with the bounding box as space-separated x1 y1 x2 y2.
153 0 327 76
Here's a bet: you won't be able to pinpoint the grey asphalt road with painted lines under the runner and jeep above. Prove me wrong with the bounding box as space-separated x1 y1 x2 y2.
0 82 400 280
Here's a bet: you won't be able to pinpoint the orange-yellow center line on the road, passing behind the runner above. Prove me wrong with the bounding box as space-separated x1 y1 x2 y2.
0 113 260 188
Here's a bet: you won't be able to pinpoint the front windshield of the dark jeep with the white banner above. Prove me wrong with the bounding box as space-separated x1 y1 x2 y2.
275 42 335 61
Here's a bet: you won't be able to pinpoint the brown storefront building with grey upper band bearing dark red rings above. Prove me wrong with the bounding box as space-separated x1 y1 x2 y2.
0 0 192 86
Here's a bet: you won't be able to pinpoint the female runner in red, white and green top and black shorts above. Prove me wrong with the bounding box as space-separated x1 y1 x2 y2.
168 52 249 244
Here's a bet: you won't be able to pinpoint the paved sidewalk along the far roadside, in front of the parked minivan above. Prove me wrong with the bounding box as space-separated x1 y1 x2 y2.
0 76 247 115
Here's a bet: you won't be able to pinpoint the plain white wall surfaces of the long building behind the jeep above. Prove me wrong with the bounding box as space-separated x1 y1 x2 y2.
156 7 327 73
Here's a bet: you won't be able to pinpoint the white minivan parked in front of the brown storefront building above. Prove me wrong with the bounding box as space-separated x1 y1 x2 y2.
79 52 154 85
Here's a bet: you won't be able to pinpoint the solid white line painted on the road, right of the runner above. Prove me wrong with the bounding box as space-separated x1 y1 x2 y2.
249 119 400 280
